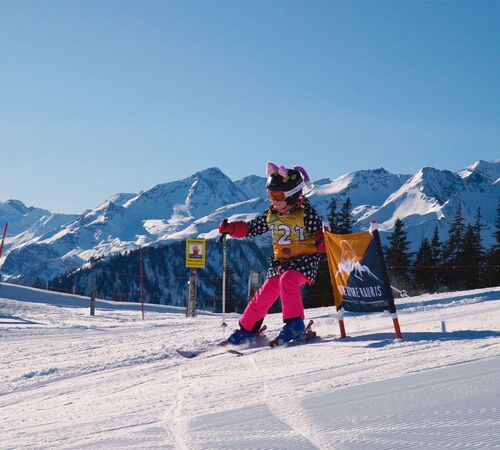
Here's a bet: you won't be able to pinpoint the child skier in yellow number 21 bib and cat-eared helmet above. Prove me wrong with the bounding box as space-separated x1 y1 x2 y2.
219 162 325 345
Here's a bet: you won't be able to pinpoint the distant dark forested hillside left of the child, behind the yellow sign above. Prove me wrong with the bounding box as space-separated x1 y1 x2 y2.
44 240 267 312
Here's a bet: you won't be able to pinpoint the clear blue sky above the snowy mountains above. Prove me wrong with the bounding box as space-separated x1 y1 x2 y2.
0 0 500 213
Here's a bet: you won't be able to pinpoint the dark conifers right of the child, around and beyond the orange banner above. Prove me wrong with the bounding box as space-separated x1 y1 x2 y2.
304 198 500 307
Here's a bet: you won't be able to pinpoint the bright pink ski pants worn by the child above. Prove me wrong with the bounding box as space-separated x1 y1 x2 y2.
240 270 310 331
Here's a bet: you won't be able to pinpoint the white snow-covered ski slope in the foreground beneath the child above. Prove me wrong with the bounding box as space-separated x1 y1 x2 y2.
0 284 500 450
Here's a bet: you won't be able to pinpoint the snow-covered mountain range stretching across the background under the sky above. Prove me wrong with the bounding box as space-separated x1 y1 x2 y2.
0 160 500 279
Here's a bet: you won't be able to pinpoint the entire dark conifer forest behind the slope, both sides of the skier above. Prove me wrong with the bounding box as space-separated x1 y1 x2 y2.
41 198 500 312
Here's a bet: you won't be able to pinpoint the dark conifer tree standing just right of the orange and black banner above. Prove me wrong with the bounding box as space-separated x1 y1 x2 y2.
385 217 410 289
